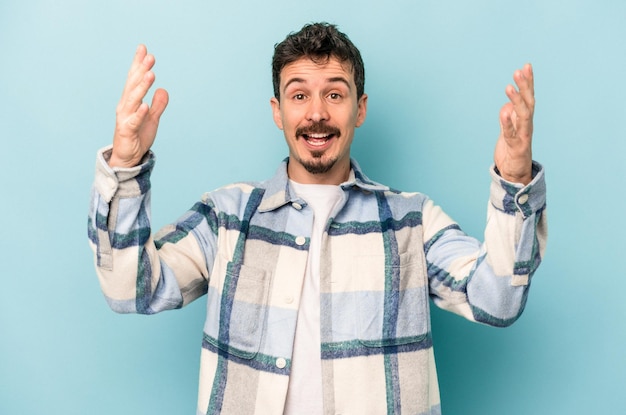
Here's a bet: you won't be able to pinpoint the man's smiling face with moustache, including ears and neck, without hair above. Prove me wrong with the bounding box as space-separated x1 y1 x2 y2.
270 58 367 184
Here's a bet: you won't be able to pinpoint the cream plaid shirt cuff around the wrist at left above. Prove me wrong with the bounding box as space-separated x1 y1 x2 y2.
94 145 155 203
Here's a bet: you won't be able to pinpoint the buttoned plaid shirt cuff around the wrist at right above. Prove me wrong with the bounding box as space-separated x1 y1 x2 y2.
490 161 546 218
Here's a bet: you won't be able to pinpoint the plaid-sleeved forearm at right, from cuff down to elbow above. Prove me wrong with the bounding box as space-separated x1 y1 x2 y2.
467 164 547 326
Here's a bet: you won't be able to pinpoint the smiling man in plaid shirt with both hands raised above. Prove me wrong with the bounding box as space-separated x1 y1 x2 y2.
89 23 546 414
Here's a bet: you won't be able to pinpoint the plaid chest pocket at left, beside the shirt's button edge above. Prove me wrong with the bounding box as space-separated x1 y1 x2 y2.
205 255 270 359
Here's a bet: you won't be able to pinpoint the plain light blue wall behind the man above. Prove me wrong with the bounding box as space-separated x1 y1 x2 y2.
0 0 626 415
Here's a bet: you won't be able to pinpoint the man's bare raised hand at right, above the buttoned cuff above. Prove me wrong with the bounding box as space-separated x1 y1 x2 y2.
494 64 535 185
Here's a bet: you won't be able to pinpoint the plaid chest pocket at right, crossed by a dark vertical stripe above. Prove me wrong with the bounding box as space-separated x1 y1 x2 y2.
353 253 430 347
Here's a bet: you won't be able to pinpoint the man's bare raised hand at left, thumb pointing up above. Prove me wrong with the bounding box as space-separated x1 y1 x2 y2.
109 45 169 167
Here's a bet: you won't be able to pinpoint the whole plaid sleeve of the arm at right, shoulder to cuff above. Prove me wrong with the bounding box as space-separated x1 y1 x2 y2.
425 165 547 326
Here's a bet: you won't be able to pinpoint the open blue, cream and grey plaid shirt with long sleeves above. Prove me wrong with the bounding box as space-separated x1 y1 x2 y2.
89 149 547 415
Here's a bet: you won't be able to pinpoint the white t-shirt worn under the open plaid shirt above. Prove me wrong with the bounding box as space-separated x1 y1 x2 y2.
284 181 343 415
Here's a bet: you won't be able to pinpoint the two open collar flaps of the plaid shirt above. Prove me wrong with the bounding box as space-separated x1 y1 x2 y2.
258 158 390 212
